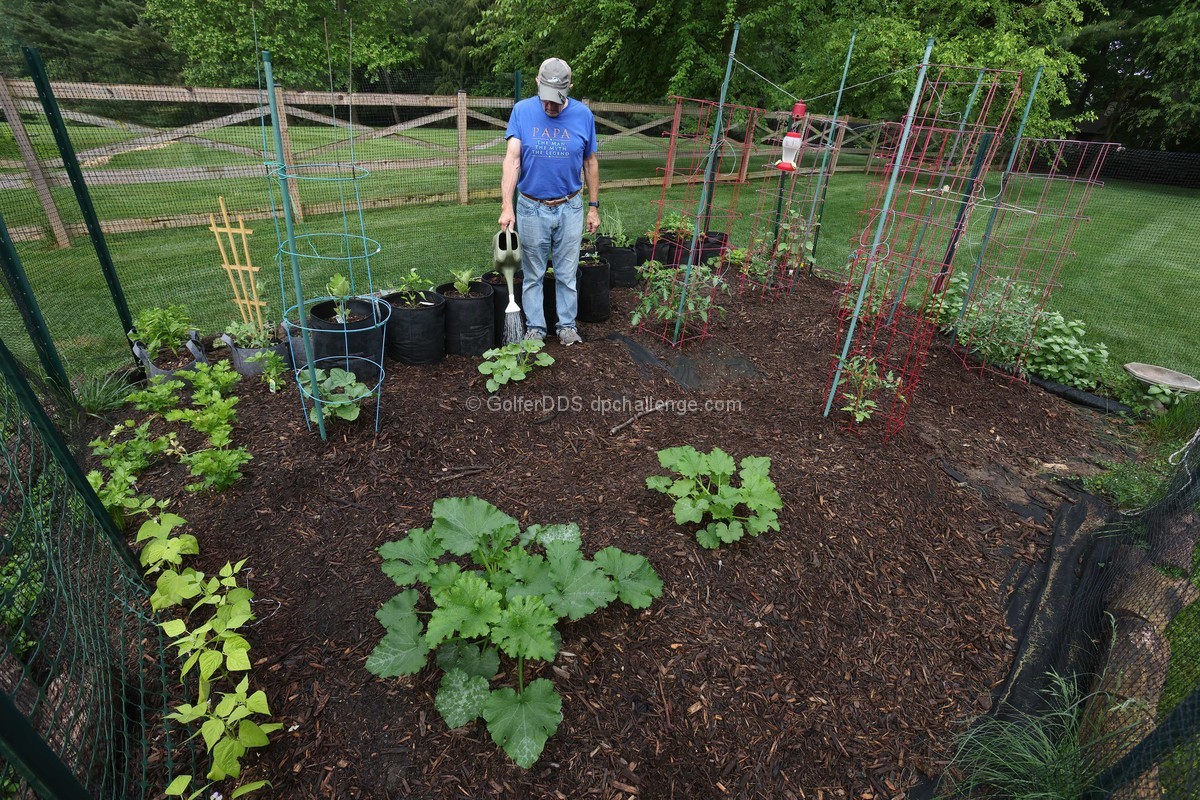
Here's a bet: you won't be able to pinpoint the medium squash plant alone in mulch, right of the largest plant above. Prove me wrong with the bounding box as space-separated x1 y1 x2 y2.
646 446 784 549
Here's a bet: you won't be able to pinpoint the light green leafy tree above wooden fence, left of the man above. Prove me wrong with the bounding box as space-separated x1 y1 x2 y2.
146 0 420 89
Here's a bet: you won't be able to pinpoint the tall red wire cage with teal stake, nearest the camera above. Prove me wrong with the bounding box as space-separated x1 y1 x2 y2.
824 40 1021 438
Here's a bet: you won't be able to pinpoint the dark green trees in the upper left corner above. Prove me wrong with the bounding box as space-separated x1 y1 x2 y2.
0 0 181 83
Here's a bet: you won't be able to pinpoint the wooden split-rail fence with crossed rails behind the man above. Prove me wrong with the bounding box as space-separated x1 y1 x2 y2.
0 76 880 247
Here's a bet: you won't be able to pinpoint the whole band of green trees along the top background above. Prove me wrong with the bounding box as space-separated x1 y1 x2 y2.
0 0 1200 150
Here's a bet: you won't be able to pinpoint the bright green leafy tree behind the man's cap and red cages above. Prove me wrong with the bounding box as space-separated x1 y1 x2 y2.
478 0 1088 134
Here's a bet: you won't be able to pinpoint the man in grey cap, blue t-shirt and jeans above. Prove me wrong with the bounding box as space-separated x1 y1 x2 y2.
500 59 600 345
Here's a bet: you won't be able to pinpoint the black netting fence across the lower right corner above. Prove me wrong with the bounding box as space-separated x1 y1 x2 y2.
940 417 1200 800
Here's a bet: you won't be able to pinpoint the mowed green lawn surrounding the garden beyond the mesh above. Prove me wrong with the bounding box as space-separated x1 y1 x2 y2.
0 118 1200 374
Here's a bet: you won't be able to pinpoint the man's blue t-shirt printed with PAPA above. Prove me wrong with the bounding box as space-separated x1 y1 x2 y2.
504 95 596 200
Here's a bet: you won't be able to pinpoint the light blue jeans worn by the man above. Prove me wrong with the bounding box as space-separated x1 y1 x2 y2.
517 192 583 333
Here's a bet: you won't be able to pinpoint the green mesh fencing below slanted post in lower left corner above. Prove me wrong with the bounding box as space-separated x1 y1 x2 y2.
0 335 196 800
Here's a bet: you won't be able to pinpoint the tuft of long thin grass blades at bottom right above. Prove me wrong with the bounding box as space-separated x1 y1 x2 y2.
940 673 1140 800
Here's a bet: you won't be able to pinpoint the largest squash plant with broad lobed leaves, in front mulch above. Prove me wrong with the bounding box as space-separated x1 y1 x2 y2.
366 498 662 769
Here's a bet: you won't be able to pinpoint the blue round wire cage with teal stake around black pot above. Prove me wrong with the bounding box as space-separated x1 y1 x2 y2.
262 50 391 439
